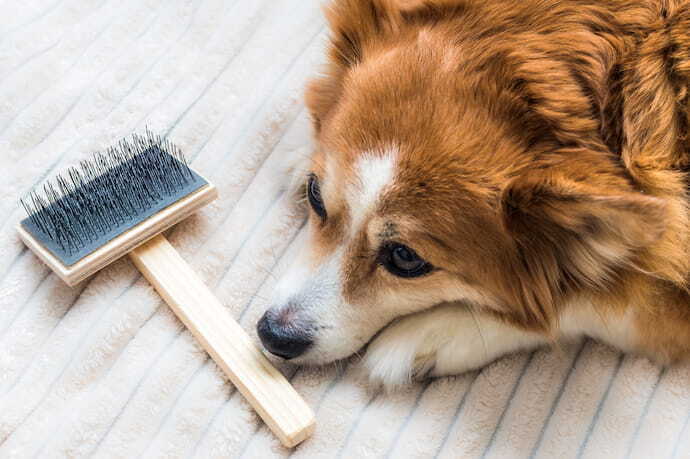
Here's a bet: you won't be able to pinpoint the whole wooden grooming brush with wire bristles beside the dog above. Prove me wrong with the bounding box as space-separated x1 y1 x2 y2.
17 131 314 447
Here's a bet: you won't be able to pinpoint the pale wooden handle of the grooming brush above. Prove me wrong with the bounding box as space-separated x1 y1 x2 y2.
129 235 314 448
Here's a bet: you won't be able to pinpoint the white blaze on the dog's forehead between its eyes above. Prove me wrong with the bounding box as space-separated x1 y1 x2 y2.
347 150 396 231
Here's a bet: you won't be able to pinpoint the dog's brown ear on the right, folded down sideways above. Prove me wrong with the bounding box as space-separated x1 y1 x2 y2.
501 176 666 330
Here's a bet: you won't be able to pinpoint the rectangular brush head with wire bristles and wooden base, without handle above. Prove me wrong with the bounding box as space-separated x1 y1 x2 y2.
19 131 217 285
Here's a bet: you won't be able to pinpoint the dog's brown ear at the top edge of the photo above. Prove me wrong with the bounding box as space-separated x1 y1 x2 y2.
305 0 401 132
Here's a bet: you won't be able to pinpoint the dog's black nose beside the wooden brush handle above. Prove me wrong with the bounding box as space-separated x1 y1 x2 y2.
256 311 313 359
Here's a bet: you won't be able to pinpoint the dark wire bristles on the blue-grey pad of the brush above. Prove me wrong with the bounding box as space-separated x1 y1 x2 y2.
21 129 198 255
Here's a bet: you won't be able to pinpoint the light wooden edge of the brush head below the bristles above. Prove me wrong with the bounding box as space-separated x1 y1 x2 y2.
17 184 218 286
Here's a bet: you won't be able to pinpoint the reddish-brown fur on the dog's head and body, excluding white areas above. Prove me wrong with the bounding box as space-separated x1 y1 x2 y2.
307 0 690 361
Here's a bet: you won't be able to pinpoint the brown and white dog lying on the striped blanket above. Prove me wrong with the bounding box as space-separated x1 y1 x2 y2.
258 0 690 384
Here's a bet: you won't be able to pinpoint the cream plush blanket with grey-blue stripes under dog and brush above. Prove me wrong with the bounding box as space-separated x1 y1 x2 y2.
0 0 690 458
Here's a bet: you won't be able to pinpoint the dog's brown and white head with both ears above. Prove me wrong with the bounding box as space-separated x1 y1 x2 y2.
258 0 664 363
